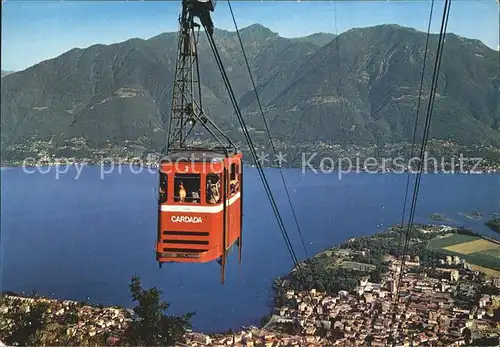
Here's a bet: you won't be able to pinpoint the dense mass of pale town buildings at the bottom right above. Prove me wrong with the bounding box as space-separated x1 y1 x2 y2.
170 251 500 347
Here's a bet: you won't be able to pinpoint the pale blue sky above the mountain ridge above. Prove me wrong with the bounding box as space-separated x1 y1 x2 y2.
2 0 499 71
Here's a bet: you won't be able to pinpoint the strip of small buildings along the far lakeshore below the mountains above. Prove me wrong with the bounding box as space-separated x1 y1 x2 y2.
2 136 500 173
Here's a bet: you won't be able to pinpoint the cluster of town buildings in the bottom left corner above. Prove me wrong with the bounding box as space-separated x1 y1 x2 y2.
0 295 131 339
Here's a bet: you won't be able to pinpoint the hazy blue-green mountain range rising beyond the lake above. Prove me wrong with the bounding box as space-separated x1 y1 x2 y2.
1 24 500 163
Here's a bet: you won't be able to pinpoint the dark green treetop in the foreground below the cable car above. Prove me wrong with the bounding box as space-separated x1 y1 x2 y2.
125 276 194 346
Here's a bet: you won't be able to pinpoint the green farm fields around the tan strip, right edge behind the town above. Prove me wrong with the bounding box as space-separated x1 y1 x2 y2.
428 234 500 270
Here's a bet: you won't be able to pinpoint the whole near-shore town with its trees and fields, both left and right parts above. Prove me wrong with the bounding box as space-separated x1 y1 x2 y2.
0 225 500 347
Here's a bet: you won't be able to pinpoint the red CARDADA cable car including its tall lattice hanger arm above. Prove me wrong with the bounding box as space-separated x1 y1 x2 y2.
156 0 243 283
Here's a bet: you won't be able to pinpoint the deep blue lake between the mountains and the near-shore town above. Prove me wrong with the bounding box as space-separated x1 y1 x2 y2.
1 166 500 332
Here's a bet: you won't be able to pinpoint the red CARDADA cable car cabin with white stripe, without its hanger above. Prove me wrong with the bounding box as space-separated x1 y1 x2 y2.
156 150 243 283
